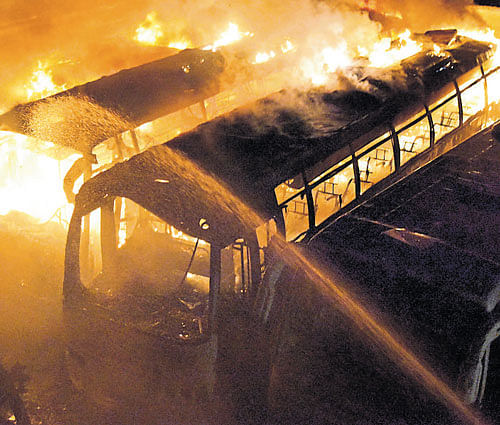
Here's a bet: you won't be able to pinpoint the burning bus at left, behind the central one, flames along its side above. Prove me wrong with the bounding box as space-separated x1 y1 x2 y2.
0 31 293 222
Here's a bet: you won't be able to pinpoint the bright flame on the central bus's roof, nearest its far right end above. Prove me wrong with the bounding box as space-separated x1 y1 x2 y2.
368 30 422 68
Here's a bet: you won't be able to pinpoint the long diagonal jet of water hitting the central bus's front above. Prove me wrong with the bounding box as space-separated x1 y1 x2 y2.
158 145 488 425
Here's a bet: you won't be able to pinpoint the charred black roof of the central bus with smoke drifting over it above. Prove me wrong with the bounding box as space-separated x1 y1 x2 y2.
74 40 494 243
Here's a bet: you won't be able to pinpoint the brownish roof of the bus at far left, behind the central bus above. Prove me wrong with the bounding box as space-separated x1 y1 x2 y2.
0 49 225 153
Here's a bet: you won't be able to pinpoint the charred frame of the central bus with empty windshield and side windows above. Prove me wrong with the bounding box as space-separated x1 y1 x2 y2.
63 34 500 420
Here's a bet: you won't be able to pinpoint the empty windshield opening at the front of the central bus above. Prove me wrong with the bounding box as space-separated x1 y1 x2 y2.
76 198 210 340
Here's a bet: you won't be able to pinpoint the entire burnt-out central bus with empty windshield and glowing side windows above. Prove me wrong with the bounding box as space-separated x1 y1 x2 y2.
63 37 500 423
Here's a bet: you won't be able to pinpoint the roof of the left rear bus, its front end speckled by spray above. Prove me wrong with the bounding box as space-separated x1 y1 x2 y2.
0 49 225 169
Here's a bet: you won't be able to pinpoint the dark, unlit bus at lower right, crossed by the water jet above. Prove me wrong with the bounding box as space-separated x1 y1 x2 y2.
261 124 500 424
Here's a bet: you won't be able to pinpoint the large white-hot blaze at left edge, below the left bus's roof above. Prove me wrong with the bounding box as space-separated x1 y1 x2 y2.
0 131 78 222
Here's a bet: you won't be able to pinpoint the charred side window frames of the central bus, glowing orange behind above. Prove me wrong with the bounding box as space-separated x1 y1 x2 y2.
279 42 500 240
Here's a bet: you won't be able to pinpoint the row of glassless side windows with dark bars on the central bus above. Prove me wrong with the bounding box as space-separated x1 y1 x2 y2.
277 65 500 240
